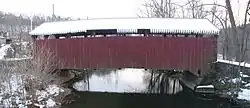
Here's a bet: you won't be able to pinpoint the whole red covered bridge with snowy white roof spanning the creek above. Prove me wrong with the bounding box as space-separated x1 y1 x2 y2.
30 18 219 74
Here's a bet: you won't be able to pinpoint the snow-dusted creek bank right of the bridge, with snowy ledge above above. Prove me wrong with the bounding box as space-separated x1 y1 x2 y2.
217 54 250 103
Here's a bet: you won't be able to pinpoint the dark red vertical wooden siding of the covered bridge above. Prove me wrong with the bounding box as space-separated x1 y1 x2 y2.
33 36 217 74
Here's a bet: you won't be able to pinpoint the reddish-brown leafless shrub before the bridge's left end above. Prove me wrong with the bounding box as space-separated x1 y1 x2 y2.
16 44 61 85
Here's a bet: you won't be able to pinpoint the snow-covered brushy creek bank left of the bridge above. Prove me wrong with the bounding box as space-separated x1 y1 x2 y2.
0 42 70 108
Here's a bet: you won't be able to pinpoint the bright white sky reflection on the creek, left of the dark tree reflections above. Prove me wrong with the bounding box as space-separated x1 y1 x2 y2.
74 69 147 92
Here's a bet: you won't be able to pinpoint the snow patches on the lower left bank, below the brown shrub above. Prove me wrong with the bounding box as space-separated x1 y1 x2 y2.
0 75 64 108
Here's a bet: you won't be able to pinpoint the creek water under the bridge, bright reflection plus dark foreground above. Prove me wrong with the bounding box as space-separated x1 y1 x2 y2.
66 69 236 108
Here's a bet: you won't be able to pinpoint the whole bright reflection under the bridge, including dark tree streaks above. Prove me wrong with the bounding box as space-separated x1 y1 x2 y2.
74 69 183 94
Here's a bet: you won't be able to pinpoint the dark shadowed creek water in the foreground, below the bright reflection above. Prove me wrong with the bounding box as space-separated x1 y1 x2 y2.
66 88 219 108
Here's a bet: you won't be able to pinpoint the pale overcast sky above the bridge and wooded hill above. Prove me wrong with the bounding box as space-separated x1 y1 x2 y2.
0 0 247 21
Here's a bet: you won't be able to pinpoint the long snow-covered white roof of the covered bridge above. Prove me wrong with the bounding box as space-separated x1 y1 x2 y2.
30 18 219 35
